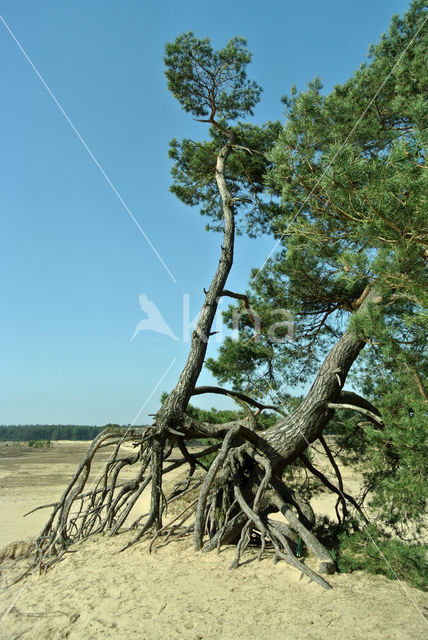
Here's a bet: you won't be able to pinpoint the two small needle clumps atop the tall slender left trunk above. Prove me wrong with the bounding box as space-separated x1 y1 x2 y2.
165 32 280 235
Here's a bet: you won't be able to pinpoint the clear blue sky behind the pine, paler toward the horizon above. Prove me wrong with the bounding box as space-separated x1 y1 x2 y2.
0 0 408 425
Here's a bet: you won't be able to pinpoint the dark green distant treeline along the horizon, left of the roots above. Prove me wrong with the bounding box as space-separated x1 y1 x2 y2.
0 424 104 442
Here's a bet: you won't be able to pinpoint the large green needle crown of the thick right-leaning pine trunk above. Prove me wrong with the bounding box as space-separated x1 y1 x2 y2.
210 1 428 390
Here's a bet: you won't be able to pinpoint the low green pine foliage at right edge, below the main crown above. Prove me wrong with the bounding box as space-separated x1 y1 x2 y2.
354 349 428 539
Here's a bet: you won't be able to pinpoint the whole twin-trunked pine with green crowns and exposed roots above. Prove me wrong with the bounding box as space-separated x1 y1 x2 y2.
28 1 427 588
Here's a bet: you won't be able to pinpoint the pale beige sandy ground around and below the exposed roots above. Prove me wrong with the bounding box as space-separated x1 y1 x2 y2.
0 442 428 640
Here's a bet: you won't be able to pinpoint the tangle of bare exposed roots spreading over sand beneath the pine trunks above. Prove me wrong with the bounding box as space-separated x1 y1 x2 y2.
20 422 342 589
